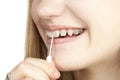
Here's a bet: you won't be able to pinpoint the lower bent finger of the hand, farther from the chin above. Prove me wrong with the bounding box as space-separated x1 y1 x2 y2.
10 62 50 80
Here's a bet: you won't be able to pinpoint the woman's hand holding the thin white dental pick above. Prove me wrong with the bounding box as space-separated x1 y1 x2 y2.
9 58 60 80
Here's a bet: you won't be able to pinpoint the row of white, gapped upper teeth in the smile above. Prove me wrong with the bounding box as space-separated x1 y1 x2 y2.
46 29 84 38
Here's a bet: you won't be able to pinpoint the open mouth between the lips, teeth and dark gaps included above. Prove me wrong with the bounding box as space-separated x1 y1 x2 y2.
46 28 85 39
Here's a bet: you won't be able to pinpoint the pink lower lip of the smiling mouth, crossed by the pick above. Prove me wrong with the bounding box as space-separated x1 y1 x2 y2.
47 31 85 45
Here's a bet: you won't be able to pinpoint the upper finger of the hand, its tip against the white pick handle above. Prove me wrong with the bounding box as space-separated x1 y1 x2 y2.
25 58 60 79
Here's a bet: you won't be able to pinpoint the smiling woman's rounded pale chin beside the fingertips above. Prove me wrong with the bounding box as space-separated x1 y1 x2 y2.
54 52 89 71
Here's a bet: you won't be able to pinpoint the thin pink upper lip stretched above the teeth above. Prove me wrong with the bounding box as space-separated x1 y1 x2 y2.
42 24 85 31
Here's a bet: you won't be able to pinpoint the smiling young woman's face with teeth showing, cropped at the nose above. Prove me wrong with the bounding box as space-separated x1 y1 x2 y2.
31 0 120 71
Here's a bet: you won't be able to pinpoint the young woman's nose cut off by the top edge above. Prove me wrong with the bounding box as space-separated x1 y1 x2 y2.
38 0 65 19
